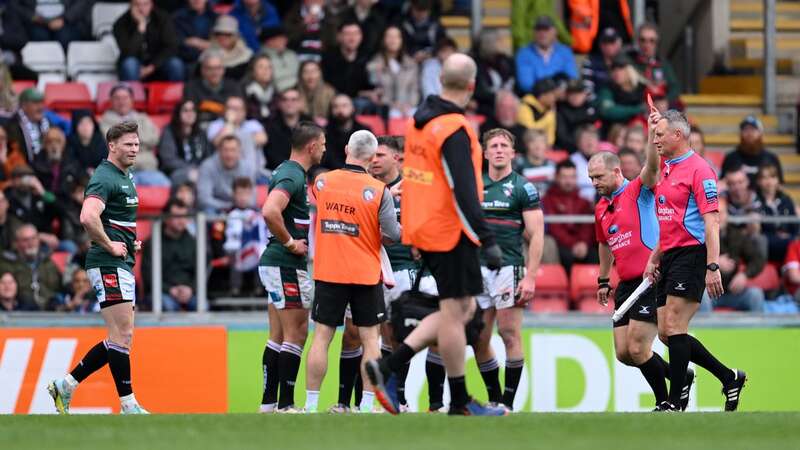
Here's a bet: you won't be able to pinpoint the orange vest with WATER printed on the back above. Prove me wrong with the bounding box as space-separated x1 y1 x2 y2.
311 169 386 285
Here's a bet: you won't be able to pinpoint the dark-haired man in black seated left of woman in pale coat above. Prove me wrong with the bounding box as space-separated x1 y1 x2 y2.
322 22 379 111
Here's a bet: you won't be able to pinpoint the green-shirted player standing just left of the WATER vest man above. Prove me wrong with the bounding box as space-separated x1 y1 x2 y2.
258 122 325 413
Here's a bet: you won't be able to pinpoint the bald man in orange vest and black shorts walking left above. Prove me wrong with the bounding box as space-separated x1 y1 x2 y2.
367 53 507 415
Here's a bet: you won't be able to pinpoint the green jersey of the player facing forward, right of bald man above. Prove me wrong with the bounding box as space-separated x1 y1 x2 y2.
481 172 539 266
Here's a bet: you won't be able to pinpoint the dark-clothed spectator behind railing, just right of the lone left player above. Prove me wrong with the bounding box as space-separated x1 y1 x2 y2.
142 199 197 312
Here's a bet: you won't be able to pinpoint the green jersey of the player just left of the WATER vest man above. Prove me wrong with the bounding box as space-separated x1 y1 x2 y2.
259 159 311 270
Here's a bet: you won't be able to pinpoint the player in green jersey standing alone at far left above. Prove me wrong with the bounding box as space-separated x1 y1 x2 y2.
47 122 147 414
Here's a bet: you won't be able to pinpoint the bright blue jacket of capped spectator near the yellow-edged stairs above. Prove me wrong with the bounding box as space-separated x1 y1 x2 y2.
516 42 578 93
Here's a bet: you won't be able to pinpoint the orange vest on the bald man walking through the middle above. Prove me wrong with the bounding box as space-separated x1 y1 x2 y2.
400 113 483 252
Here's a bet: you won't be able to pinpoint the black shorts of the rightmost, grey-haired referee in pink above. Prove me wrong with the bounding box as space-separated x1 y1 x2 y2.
657 245 706 308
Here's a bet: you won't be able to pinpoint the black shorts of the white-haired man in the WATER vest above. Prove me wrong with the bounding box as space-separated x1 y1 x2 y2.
311 280 387 327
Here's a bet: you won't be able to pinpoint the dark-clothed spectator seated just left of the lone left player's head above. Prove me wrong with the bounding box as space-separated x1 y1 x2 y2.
67 109 108 173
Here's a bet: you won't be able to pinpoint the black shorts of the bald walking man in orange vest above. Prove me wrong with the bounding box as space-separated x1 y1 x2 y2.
421 234 483 299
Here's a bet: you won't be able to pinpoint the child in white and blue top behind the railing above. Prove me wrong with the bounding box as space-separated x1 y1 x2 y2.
223 178 269 296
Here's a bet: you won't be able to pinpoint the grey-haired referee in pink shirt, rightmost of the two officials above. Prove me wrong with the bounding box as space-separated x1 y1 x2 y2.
645 110 747 411
